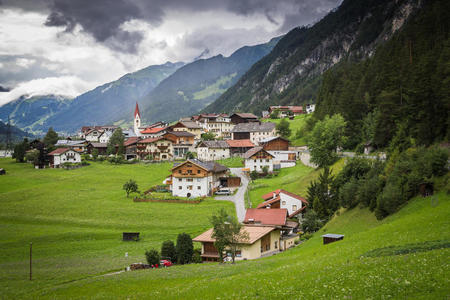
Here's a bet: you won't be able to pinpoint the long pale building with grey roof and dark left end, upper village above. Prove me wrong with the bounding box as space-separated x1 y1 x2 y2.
231 122 277 144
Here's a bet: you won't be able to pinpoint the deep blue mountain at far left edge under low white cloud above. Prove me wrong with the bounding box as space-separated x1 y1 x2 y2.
0 95 71 133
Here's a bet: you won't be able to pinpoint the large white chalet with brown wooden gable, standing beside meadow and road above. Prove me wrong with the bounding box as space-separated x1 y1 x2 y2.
171 159 228 197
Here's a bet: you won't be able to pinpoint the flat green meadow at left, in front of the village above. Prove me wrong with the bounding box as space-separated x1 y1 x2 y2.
0 159 234 298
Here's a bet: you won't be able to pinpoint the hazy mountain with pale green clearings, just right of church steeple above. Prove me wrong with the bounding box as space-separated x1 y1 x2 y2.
137 37 280 122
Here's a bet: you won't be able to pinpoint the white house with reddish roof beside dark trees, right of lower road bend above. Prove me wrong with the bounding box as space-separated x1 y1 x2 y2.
257 189 308 218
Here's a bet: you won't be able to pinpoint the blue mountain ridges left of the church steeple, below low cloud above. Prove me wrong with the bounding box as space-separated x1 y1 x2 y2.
0 62 184 134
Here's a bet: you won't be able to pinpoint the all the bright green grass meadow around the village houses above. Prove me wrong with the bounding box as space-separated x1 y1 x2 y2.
0 160 450 299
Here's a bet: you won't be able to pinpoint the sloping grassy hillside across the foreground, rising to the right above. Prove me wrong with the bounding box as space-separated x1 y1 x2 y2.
34 188 450 299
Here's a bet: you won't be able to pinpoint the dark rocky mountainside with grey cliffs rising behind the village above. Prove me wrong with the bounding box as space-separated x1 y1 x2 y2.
204 0 420 113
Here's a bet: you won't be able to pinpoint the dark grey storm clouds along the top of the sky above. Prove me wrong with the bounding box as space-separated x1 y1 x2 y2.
0 0 341 53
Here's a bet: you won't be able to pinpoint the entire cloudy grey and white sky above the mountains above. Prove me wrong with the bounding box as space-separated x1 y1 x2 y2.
0 0 342 105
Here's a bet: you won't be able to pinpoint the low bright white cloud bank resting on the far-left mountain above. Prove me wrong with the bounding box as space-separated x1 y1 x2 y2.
0 76 90 105
